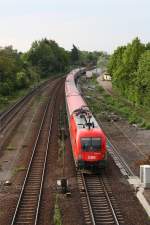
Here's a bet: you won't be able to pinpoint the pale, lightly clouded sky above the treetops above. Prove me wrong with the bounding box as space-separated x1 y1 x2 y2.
0 0 150 53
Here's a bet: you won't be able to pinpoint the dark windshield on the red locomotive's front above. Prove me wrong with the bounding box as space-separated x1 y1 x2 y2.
81 137 101 152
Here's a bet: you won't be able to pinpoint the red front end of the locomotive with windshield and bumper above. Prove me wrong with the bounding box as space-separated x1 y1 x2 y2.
76 129 107 168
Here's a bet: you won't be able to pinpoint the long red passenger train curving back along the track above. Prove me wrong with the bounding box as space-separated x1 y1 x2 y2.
65 68 107 169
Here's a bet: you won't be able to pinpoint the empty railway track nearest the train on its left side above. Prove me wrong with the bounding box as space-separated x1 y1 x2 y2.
11 80 61 225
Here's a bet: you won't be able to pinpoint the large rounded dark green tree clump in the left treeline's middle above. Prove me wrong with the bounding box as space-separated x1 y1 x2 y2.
27 39 69 77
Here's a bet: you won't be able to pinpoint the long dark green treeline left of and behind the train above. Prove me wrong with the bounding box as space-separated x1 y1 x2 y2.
0 39 105 101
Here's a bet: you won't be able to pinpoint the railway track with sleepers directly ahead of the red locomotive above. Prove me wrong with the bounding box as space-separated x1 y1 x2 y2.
77 172 125 225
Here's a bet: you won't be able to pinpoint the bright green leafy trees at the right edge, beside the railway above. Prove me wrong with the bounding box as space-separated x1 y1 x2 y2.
108 38 150 106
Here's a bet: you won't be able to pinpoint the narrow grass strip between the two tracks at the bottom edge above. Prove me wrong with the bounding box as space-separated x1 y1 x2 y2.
53 194 62 225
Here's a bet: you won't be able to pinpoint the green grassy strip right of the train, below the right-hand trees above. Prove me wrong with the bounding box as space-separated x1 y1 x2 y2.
81 78 150 129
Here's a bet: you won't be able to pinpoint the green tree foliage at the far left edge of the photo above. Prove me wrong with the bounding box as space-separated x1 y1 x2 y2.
0 46 35 96
